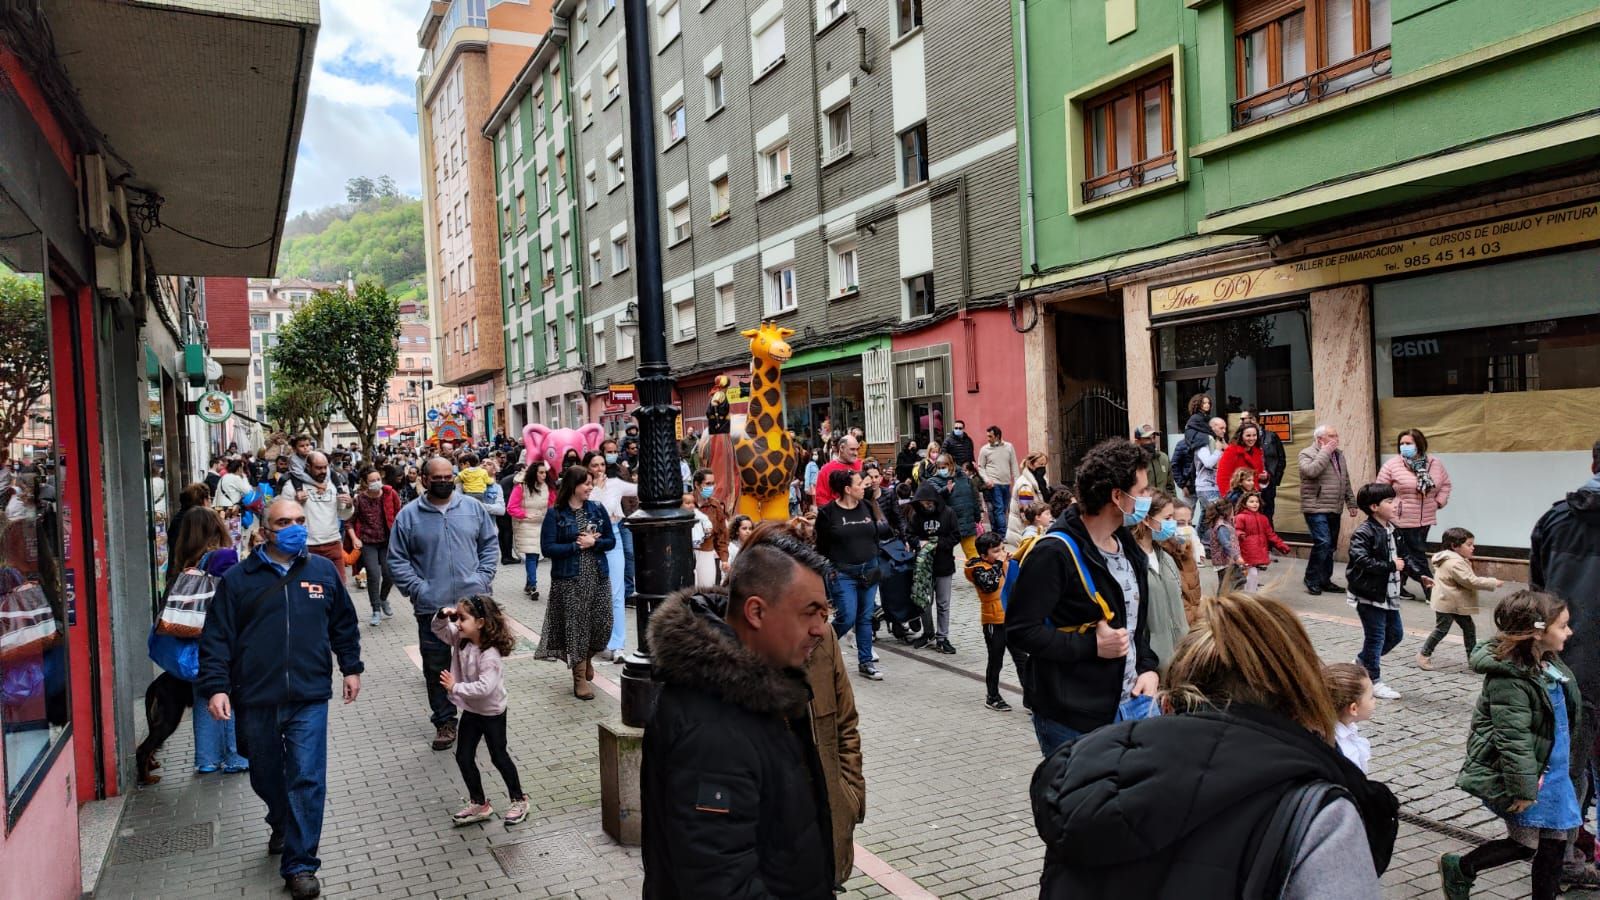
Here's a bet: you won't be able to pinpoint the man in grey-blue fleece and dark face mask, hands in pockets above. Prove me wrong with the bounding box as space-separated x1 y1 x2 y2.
389 456 499 749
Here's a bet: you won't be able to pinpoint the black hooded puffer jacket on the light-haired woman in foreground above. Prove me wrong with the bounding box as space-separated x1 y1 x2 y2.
1030 703 1398 900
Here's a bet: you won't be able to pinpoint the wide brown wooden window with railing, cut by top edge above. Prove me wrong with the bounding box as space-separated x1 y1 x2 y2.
1234 0 1390 127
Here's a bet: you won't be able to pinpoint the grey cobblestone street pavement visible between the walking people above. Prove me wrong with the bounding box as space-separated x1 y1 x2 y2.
94 550 1587 900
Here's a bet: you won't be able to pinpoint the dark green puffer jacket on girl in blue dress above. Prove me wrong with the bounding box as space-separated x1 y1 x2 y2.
1456 641 1582 814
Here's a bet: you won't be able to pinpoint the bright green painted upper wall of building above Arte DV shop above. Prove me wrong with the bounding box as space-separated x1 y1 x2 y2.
1013 0 1600 271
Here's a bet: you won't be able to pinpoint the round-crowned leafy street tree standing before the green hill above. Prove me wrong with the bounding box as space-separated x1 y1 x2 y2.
272 280 400 458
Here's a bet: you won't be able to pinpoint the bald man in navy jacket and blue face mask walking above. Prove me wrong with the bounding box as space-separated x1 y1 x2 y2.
197 498 363 897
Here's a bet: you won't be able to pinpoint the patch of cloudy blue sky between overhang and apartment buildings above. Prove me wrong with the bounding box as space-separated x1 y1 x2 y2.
290 0 427 216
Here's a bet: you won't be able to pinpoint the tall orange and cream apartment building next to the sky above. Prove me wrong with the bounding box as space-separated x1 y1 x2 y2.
402 0 550 437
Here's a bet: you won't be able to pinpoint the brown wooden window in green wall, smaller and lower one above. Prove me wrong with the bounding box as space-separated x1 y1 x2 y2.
1083 66 1178 202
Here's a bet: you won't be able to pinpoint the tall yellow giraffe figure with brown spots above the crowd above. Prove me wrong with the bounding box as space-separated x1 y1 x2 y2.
733 322 795 522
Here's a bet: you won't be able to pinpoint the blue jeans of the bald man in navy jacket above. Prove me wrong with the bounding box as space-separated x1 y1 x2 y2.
234 700 328 878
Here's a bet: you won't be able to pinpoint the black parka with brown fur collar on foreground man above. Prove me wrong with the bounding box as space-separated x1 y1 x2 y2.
638 591 835 900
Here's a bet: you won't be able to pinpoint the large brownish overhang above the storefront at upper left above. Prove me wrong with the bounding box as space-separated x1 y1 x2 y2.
43 0 320 275
